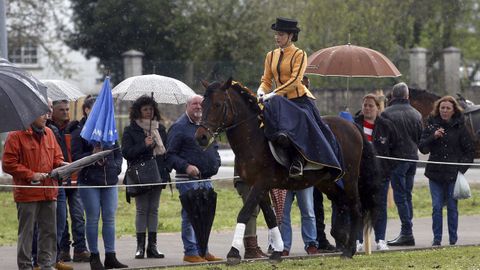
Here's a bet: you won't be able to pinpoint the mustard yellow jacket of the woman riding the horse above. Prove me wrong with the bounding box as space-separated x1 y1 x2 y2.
260 44 315 99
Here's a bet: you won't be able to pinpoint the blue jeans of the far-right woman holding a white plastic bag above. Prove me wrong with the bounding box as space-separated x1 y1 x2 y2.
428 180 458 245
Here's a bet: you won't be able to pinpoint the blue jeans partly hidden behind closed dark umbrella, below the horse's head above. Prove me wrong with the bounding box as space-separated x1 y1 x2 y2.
177 179 213 256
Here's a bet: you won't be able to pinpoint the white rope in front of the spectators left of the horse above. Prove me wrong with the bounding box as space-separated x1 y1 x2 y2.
0 176 240 189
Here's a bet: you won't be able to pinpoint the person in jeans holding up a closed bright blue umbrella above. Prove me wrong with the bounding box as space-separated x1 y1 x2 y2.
72 77 128 269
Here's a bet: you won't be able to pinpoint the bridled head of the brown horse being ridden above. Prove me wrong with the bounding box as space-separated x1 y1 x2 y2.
195 78 257 147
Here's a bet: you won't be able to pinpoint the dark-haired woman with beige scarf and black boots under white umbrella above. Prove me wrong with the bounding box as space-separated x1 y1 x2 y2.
122 96 170 259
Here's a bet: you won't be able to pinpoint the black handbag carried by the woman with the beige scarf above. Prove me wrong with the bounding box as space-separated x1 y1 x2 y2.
125 157 162 197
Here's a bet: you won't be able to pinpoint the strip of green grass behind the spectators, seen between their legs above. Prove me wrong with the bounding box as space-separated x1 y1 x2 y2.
0 183 480 245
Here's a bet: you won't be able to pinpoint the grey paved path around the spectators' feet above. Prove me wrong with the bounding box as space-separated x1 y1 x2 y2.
0 216 480 270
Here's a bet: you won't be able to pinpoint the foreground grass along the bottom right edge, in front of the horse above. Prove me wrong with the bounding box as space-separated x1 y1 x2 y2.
168 247 480 270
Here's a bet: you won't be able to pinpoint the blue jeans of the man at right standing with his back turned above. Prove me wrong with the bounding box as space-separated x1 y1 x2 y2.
391 161 417 235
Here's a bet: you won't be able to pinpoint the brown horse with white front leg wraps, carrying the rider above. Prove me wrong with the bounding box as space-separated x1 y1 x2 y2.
195 79 380 264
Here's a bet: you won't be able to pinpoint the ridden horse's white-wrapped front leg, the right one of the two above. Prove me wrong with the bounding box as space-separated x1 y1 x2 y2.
259 192 283 262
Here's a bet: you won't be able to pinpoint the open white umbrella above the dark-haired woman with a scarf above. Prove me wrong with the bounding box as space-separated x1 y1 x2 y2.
112 74 195 104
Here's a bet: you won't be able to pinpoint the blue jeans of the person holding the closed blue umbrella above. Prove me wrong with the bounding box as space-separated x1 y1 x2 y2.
79 186 118 254
